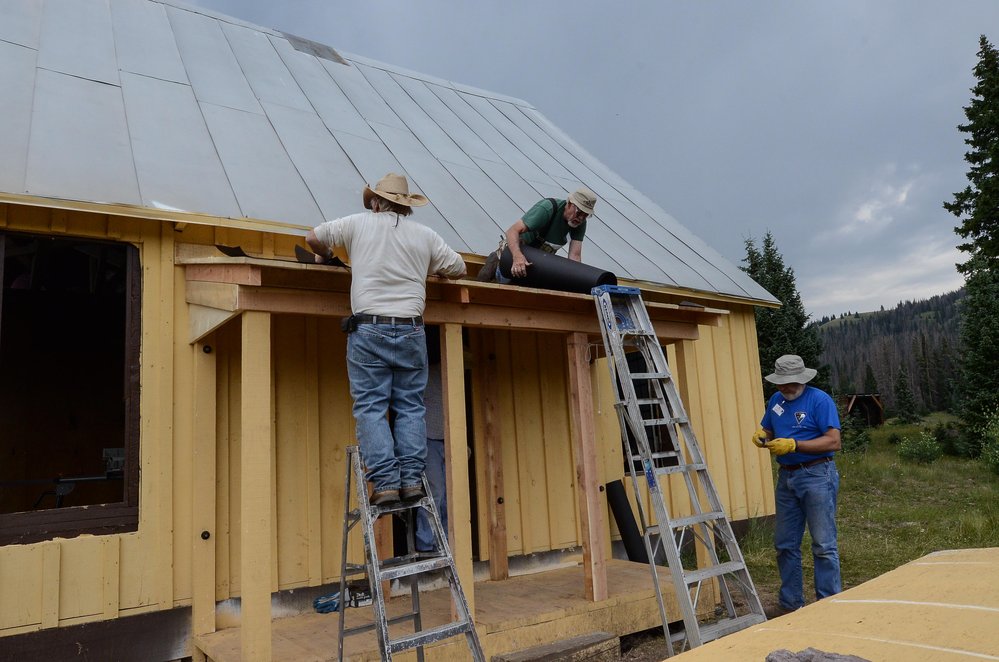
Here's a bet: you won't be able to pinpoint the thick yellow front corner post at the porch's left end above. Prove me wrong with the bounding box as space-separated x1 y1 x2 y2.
239 311 274 662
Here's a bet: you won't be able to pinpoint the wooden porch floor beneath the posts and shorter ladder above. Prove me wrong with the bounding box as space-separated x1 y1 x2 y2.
198 560 679 662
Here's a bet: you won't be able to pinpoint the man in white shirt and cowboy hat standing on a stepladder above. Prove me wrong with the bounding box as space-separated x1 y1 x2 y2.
306 173 465 506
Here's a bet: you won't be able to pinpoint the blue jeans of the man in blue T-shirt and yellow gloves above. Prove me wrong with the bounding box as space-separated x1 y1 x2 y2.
774 462 842 610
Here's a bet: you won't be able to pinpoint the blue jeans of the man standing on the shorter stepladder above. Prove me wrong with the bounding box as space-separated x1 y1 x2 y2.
347 324 427 492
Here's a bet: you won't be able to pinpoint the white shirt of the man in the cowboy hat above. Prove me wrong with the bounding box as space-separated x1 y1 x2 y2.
315 212 465 317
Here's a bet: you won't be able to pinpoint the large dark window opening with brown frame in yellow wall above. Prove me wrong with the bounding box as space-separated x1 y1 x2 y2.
0 233 140 545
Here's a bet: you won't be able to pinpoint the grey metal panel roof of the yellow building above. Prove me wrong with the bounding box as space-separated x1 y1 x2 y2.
0 0 774 301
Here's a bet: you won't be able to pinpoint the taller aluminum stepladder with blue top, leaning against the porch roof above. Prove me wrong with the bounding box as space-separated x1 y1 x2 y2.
592 285 767 656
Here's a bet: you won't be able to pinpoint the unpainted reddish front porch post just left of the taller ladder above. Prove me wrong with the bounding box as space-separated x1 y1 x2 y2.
568 333 607 602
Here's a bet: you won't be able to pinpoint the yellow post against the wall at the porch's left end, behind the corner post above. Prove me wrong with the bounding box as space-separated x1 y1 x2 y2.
191 336 216 660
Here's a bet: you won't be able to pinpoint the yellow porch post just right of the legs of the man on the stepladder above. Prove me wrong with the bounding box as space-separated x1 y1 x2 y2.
441 324 475 618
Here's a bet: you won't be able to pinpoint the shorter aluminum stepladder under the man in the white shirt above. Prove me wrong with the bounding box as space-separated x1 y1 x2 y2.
337 446 485 662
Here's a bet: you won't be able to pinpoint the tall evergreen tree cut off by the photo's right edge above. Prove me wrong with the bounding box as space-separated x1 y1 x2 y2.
944 35 999 438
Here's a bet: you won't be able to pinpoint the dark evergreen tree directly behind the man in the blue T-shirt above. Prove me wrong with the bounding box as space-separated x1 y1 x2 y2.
740 232 830 396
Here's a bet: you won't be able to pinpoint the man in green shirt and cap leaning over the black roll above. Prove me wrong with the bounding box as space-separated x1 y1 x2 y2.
476 186 597 283
